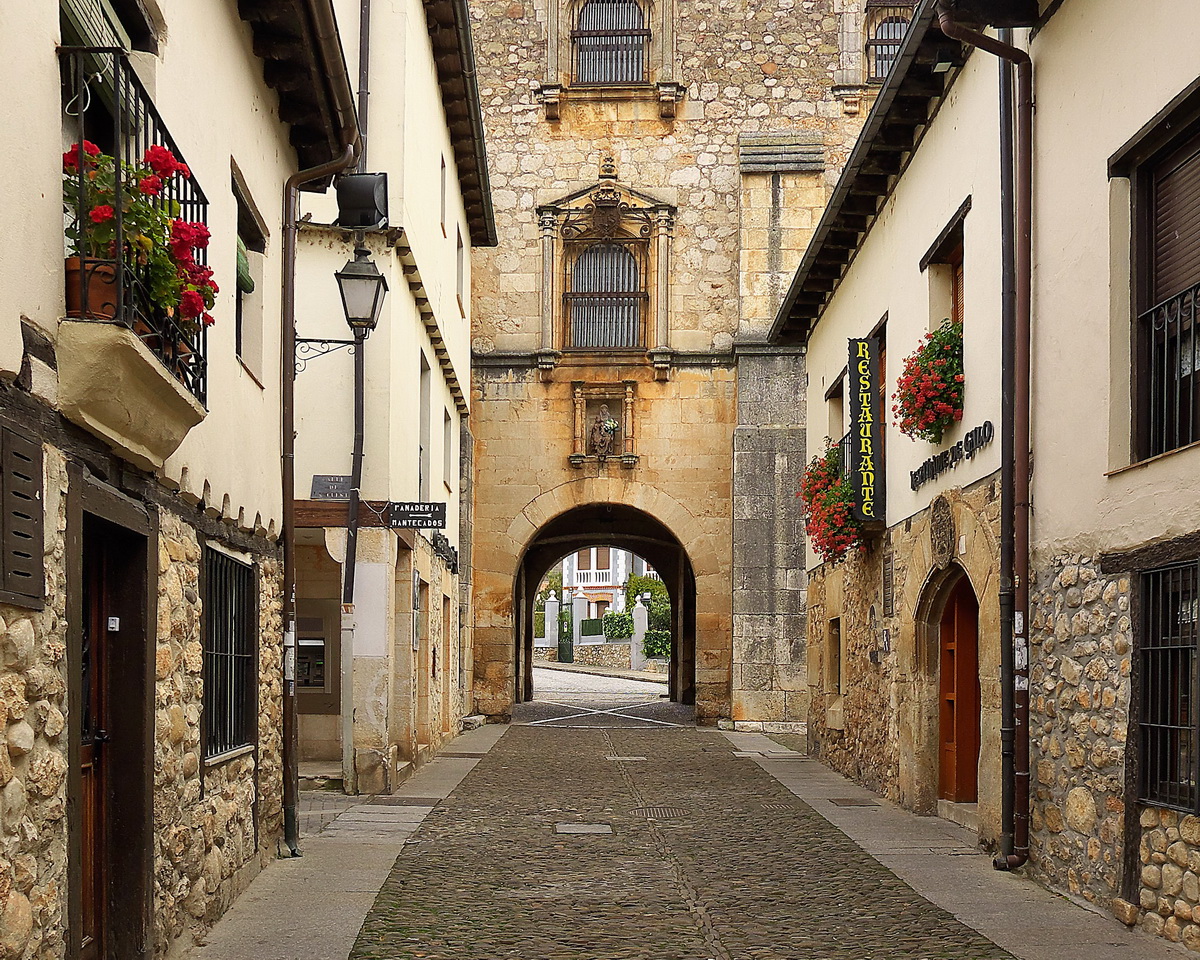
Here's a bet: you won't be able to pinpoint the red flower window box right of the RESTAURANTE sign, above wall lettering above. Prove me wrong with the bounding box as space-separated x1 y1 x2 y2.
892 319 964 444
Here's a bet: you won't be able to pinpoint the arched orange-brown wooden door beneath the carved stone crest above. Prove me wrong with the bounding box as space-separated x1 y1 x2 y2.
937 577 979 803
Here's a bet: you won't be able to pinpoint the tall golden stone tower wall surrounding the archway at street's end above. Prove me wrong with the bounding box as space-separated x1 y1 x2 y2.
472 0 863 721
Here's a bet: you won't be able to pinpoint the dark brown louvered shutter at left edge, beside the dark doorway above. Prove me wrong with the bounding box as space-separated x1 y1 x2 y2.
0 425 46 610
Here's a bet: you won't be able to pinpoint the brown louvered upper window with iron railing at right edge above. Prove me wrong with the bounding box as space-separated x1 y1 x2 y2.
1135 133 1200 457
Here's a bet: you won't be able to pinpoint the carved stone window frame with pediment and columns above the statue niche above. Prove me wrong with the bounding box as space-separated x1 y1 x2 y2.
538 174 676 370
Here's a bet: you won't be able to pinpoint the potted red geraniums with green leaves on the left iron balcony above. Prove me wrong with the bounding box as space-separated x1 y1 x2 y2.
62 140 217 334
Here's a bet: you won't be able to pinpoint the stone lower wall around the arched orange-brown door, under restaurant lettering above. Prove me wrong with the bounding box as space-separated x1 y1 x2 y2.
808 476 1001 840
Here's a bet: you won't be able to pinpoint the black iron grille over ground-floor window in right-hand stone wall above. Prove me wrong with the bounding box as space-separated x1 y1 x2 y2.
1139 560 1200 814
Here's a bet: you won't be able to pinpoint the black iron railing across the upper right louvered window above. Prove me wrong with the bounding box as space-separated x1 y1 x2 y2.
1139 284 1200 457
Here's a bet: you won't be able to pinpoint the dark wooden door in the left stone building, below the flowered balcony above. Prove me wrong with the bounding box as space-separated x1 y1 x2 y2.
79 538 110 960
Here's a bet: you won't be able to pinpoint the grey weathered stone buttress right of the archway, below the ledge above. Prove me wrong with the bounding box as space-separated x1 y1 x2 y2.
732 353 809 721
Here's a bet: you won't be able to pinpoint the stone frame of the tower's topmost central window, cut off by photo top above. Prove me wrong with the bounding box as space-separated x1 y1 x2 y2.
536 0 685 121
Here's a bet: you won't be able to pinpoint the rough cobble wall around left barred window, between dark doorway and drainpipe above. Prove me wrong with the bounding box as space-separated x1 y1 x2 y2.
154 511 283 956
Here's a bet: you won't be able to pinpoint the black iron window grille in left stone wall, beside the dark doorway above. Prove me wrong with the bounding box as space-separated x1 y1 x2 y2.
204 548 258 757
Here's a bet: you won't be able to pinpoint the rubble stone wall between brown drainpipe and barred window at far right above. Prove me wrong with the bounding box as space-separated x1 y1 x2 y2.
1030 556 1128 907
